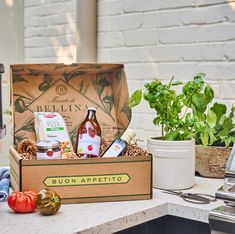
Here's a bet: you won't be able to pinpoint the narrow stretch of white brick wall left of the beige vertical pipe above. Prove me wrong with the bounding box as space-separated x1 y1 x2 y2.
24 0 77 63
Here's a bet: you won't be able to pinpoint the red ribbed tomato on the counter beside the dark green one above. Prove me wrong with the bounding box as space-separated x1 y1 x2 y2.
7 191 37 213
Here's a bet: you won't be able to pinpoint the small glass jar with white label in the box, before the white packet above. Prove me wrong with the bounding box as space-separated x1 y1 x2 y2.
35 140 61 159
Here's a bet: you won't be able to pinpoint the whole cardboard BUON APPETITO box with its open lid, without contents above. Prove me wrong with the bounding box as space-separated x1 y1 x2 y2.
9 64 152 203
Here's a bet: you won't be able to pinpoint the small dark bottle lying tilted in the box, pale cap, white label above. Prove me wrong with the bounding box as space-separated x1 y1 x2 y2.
101 129 136 157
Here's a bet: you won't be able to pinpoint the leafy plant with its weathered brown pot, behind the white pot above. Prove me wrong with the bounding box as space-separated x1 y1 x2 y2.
194 103 235 178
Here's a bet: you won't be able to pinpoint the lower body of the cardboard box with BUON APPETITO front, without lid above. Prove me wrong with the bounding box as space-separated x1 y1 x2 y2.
10 147 152 203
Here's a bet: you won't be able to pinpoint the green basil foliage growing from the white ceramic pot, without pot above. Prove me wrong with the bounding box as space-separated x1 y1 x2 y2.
129 73 214 141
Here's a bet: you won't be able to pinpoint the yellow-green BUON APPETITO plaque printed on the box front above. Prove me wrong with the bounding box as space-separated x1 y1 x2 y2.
43 173 131 187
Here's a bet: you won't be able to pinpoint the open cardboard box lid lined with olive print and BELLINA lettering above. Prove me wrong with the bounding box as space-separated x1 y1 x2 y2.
10 64 131 145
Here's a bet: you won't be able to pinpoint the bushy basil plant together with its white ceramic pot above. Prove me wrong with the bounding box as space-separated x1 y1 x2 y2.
129 73 214 189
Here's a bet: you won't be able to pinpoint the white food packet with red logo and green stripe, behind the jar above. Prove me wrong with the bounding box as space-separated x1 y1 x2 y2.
34 112 70 142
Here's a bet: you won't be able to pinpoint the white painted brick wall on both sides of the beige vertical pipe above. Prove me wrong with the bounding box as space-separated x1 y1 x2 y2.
21 0 235 146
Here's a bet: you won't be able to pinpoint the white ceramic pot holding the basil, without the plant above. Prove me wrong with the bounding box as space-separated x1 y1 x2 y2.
148 138 195 190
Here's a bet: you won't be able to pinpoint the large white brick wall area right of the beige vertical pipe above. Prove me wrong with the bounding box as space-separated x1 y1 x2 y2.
97 0 235 145
